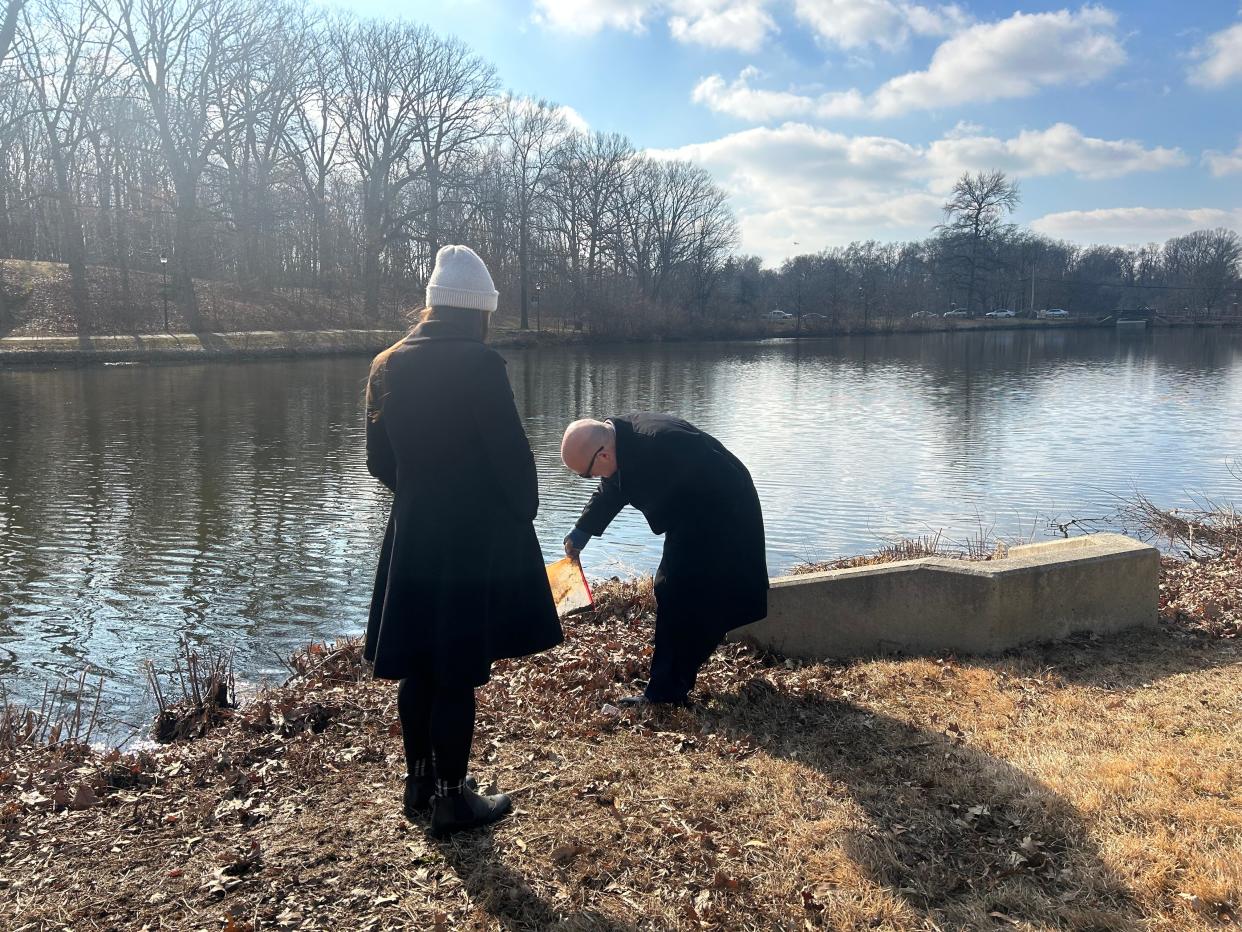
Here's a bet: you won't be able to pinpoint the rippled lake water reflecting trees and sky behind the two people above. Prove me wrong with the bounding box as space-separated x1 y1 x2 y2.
0 331 1242 733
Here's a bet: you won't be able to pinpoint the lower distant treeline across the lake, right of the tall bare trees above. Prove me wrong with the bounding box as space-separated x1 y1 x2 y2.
745 219 1242 326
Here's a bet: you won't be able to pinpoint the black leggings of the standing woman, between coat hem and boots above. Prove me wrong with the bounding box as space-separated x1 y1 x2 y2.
396 676 474 784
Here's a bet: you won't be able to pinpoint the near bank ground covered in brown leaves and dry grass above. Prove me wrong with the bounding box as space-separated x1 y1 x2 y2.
0 567 1242 932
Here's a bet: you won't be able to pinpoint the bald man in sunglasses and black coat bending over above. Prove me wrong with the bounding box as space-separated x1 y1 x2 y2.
560 414 768 705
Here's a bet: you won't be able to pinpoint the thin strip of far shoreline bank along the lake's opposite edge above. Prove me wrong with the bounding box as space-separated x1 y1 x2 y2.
0 321 1222 367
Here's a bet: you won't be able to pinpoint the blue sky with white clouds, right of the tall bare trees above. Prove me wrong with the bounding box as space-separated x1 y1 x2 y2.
330 0 1242 261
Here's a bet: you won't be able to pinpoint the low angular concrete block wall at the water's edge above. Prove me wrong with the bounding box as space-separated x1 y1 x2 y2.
729 534 1160 657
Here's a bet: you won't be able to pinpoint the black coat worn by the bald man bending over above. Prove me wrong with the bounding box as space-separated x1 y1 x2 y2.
578 414 768 636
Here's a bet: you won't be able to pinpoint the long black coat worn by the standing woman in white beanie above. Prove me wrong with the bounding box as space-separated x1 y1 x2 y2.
365 321 563 686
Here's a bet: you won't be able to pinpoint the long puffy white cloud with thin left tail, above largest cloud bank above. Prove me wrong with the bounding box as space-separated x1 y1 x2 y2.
692 6 1125 122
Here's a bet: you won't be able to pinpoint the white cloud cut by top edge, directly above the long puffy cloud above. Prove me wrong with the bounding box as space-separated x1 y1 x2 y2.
794 0 970 50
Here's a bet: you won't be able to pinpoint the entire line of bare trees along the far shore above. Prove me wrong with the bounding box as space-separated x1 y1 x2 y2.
0 0 1238 333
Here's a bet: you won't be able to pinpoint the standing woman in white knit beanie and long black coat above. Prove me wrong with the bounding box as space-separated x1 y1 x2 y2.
365 246 561 835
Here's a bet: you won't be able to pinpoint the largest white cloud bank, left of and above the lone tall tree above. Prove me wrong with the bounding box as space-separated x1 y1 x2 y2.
651 122 1186 260
